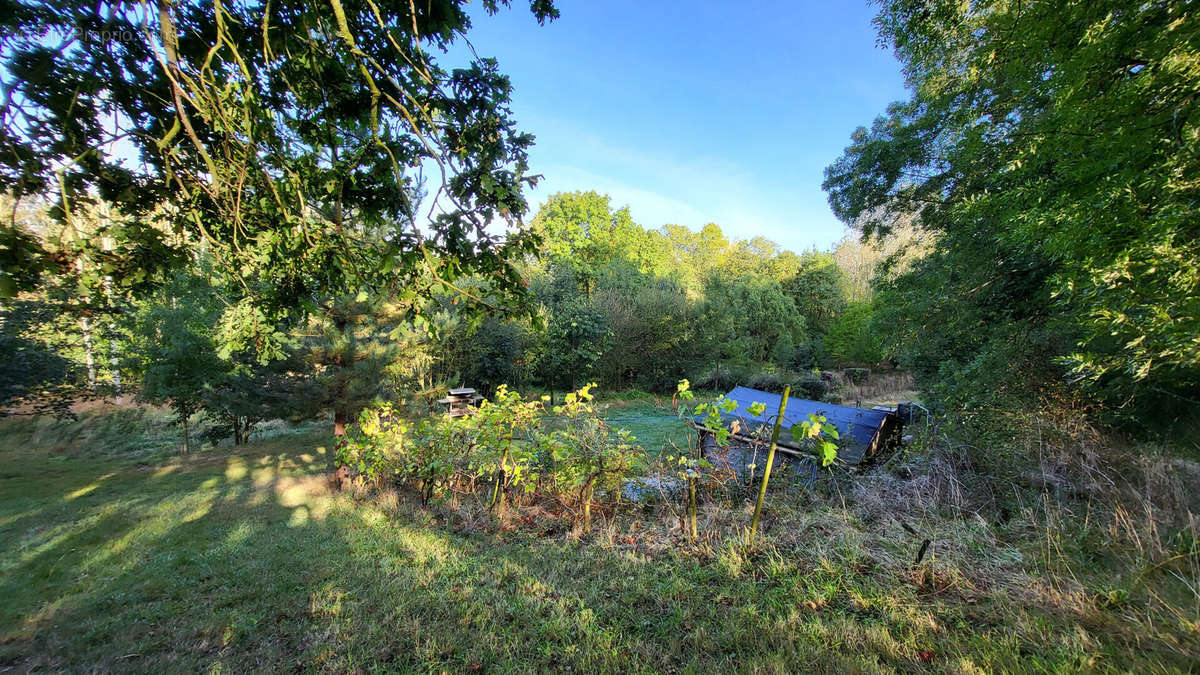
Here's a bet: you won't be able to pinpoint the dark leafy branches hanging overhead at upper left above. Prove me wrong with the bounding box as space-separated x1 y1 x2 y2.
0 0 557 326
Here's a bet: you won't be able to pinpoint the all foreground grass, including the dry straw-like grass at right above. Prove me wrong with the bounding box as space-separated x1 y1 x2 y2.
0 401 1200 673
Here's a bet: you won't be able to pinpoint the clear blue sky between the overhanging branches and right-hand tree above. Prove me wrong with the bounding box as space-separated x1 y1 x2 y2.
453 0 907 250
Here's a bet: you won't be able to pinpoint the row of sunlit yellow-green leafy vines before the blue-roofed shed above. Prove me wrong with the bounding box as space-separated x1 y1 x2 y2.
336 380 839 540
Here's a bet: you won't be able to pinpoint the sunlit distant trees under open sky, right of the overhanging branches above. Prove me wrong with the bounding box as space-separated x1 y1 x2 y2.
443 192 882 392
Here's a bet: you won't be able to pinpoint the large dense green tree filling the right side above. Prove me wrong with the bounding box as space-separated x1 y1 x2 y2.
824 0 1200 414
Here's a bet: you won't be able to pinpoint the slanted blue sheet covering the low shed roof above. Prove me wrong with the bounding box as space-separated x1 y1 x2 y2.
696 387 888 455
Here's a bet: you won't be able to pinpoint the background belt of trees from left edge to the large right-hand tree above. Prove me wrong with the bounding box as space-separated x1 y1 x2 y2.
0 186 902 442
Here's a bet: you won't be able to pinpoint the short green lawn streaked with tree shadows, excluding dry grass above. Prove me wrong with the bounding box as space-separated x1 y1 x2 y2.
0 438 1185 671
